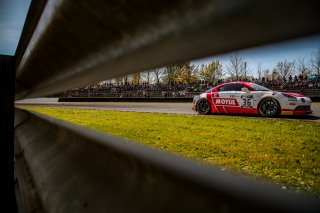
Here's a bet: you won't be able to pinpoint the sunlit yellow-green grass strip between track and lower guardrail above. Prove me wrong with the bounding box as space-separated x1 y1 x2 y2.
20 107 320 197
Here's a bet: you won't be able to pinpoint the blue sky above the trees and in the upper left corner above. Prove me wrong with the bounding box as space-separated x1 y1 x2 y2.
0 0 320 76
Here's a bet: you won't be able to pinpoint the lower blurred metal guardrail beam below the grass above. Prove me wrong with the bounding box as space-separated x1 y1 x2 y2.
15 110 320 213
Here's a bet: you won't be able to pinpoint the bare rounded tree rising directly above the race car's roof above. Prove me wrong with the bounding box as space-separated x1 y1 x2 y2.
227 54 247 81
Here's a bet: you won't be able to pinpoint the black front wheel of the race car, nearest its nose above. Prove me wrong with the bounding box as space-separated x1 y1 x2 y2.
258 98 281 117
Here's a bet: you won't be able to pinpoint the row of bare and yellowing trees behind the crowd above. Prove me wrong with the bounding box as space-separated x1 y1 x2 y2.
106 48 320 85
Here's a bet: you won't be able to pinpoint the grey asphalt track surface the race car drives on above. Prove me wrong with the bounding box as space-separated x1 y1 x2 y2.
16 102 320 121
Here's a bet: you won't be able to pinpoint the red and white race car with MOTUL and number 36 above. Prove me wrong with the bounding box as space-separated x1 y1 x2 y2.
192 81 312 117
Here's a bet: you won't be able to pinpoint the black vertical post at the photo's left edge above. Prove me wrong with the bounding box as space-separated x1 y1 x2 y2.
0 55 17 212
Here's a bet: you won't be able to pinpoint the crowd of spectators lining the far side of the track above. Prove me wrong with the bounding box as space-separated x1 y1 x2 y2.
59 75 320 98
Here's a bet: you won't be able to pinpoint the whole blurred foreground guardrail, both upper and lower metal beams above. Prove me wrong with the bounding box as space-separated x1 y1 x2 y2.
1 0 320 212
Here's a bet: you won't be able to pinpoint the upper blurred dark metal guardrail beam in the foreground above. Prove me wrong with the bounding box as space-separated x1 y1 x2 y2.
16 0 320 99
